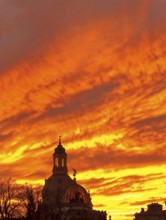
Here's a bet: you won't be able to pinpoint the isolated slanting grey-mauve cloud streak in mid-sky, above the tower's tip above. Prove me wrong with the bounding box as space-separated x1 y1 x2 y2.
30 79 118 123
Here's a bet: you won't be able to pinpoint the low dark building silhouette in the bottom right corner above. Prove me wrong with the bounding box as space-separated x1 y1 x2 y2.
134 203 166 220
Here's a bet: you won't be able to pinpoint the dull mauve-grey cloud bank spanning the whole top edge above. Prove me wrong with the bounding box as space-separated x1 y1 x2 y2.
0 0 165 73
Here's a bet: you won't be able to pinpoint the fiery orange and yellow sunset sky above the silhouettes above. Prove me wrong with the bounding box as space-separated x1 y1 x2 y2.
0 0 166 220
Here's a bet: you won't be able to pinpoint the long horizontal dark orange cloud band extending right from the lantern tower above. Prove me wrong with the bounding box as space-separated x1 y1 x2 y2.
69 146 166 171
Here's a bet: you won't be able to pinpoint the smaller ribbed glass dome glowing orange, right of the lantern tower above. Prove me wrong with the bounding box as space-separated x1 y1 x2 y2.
62 180 92 208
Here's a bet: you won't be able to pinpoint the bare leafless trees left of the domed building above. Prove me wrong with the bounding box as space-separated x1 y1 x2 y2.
0 177 42 219
